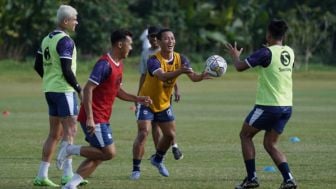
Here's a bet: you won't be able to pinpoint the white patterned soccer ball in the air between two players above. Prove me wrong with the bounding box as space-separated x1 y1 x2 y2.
205 55 227 77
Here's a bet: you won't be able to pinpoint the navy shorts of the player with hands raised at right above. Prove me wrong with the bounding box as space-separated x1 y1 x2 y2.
245 105 292 134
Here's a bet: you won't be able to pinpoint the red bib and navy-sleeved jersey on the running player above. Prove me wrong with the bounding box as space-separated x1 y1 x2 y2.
78 54 123 124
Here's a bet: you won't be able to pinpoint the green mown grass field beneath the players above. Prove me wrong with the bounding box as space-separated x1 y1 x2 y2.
0 59 336 189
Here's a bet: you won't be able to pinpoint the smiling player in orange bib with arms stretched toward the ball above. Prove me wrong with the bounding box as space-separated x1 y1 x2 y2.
130 29 210 180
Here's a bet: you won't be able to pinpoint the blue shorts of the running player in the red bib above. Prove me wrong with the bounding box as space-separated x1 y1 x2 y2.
81 123 113 148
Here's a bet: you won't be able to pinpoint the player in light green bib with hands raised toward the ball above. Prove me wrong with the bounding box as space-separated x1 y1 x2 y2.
227 20 297 189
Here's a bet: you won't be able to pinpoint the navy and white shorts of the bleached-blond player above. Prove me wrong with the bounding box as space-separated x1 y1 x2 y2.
45 92 78 117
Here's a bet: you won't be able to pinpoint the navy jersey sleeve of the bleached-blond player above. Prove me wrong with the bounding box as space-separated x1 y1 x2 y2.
56 36 75 59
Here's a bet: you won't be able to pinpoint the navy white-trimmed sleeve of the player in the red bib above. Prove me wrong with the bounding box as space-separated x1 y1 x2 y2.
89 60 112 85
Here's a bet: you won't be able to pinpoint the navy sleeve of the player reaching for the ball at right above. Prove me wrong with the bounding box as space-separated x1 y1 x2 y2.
245 48 272 67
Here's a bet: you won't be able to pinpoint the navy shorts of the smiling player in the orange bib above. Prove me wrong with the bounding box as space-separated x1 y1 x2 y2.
136 104 175 122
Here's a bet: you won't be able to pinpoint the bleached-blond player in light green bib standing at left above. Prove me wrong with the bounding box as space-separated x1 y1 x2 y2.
34 5 82 187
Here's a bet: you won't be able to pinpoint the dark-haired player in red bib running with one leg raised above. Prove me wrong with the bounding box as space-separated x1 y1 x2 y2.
59 30 152 189
